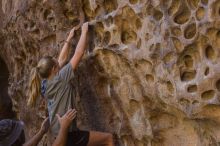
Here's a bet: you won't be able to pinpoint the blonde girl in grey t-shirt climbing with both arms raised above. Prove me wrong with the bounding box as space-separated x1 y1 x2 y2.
28 22 113 146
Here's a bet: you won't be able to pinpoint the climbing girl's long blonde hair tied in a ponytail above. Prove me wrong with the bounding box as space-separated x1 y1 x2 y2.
27 56 56 107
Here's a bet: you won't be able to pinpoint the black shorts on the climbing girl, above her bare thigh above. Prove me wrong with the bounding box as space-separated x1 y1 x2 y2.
66 130 89 146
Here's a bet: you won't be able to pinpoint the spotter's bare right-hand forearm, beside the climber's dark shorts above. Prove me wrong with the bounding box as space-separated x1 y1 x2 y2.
52 127 68 146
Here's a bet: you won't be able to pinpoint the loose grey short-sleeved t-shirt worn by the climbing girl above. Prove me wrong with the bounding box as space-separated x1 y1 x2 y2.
44 63 77 136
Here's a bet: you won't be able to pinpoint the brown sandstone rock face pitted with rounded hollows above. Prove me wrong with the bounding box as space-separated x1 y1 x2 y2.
0 0 220 146
